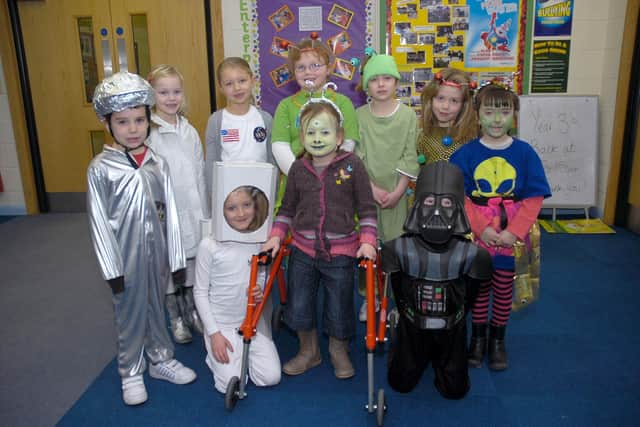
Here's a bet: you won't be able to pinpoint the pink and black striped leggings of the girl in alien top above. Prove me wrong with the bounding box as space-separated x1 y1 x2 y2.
471 270 514 326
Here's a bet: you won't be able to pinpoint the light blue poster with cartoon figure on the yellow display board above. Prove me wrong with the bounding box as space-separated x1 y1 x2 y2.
464 0 520 69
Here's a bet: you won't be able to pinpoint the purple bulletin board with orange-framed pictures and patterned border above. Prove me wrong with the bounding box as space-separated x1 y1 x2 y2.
251 0 374 114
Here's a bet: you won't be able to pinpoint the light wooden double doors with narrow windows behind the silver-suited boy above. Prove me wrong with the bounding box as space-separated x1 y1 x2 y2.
18 0 210 211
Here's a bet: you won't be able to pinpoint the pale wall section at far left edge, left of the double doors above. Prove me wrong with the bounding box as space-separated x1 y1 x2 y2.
0 57 27 215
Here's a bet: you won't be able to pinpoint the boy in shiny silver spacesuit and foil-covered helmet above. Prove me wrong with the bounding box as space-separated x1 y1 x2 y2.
87 72 196 405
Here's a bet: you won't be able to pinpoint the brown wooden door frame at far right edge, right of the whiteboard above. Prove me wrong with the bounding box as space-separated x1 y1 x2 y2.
603 0 640 224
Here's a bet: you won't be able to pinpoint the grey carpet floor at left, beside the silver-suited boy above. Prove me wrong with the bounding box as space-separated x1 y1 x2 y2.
0 214 115 426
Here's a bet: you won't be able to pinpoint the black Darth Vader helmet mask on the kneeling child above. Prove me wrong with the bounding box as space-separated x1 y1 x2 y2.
404 161 470 244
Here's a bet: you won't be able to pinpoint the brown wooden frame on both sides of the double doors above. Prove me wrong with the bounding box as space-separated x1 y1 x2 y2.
0 0 224 215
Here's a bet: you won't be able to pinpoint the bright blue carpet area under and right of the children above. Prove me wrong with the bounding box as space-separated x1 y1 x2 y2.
59 230 640 427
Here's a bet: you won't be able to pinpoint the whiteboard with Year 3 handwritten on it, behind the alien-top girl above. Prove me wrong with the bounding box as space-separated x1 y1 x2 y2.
518 96 598 208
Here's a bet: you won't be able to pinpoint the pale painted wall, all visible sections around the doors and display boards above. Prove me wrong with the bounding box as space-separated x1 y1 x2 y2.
0 0 627 215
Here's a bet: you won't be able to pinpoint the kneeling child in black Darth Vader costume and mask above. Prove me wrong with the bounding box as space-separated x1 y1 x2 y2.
382 161 491 399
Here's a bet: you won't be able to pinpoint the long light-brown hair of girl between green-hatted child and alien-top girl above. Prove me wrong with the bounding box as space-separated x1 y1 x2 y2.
420 68 478 142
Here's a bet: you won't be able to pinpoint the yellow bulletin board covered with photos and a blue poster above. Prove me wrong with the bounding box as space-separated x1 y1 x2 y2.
387 0 526 113
